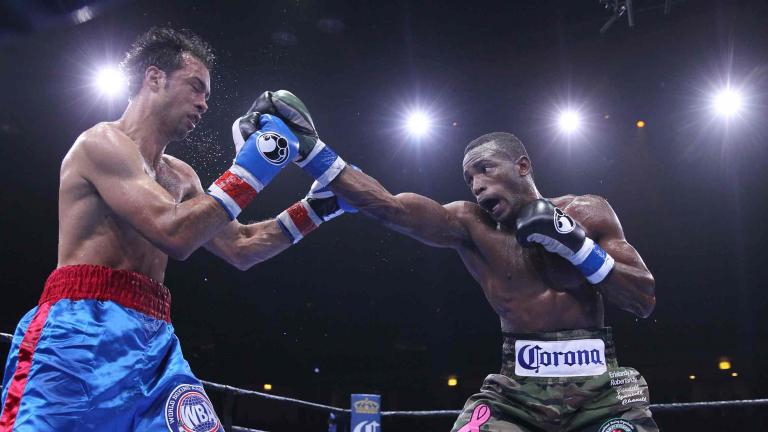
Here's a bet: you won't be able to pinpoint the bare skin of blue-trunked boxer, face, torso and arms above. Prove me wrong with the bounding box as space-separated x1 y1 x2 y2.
58 54 290 282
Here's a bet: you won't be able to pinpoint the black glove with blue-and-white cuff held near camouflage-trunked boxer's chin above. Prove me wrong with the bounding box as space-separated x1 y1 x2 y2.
516 199 615 284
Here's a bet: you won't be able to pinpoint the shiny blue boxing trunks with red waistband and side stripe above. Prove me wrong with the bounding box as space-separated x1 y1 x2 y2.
0 265 224 432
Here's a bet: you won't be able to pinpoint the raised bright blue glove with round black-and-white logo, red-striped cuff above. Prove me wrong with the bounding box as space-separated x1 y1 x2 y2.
208 112 299 219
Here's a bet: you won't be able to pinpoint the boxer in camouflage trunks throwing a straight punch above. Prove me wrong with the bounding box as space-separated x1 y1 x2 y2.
257 91 658 432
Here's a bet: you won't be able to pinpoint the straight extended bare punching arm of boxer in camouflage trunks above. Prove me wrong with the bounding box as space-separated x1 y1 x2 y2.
329 167 470 248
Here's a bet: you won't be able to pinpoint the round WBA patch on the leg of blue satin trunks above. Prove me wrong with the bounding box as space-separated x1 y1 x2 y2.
165 384 221 432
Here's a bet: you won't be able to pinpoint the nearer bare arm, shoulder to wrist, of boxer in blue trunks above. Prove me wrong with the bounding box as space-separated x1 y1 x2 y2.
74 127 229 260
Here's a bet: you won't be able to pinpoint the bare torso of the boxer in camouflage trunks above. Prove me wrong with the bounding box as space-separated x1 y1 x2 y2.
453 196 603 332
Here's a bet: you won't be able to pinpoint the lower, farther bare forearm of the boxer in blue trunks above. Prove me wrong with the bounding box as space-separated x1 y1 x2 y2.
205 219 292 270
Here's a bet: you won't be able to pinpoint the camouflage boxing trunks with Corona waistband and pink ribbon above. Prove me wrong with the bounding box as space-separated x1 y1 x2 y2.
452 327 659 432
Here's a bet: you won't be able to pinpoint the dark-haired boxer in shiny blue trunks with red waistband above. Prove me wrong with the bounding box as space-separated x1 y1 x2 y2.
0 29 352 432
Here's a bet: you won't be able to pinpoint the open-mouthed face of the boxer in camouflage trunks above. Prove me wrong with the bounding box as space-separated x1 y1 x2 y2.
463 142 530 223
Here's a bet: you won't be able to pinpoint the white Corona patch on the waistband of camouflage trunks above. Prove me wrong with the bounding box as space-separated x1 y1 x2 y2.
515 339 607 377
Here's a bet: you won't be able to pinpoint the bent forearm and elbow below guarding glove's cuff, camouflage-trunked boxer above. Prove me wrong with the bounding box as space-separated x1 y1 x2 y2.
596 262 656 318
